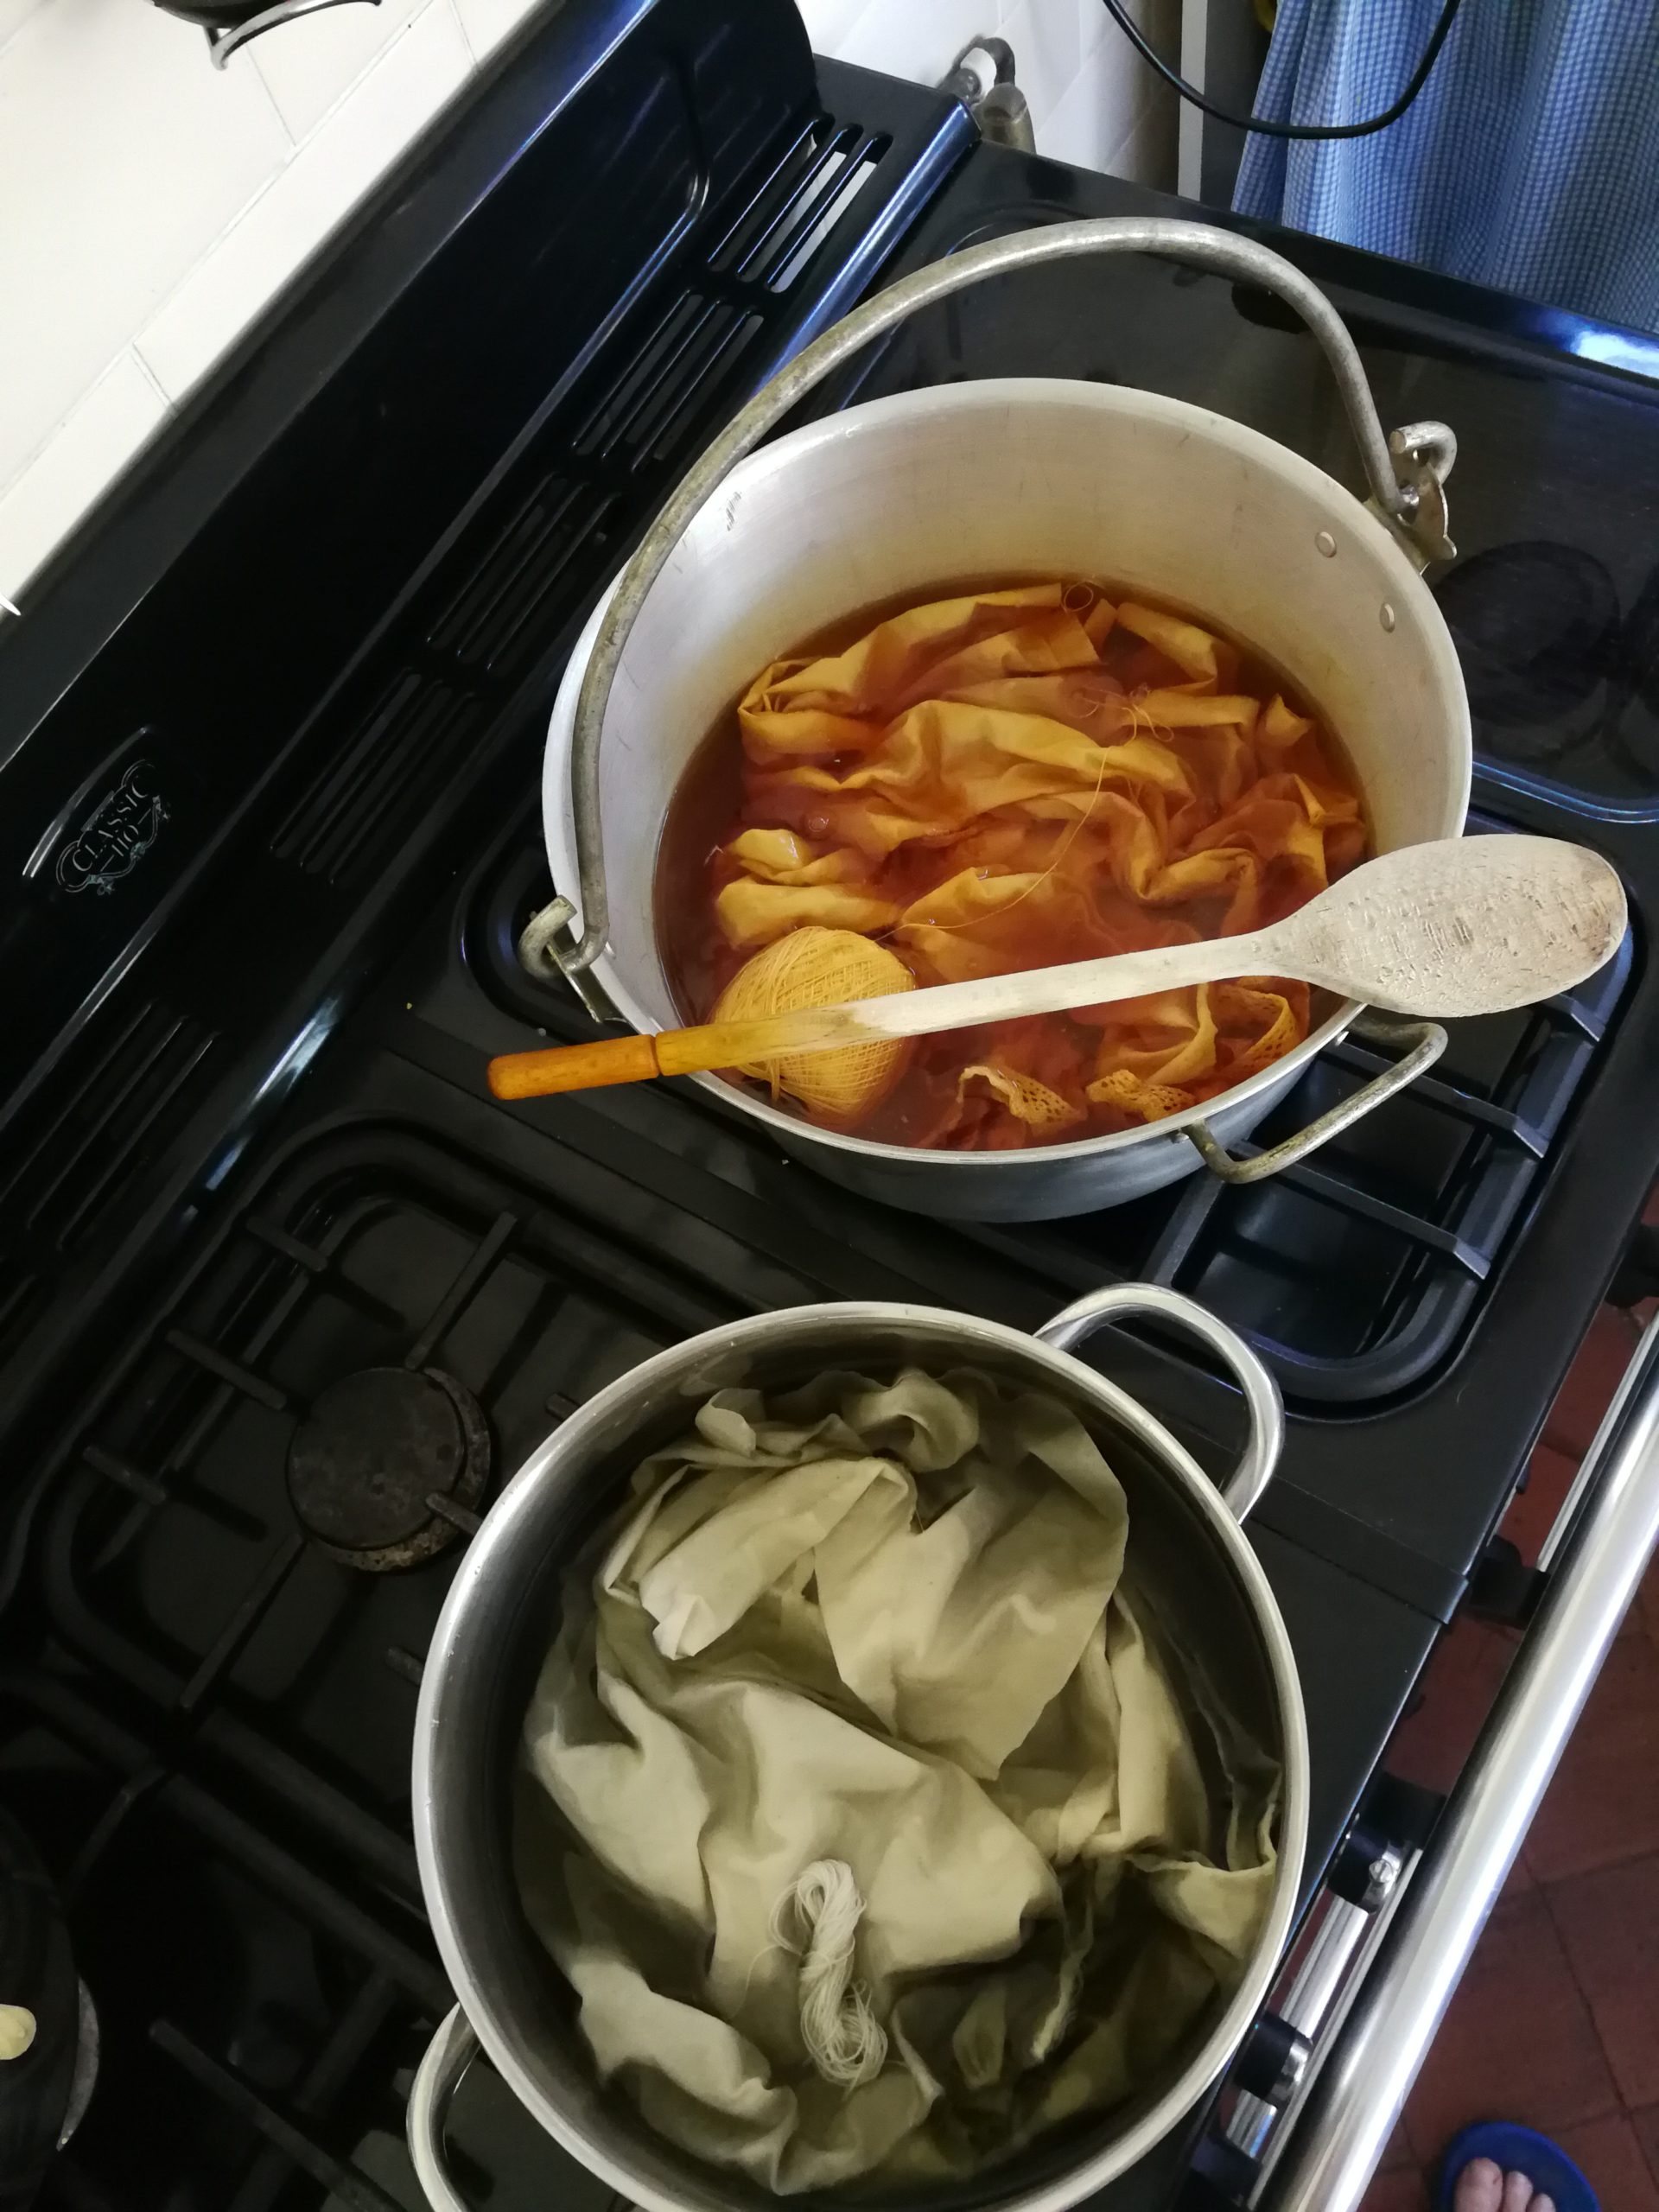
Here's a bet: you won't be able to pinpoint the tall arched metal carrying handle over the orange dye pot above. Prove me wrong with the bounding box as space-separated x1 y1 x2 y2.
555 214 1458 978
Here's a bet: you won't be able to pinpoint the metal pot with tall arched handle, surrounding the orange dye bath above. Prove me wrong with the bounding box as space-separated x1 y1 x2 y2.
520 219 1471 1221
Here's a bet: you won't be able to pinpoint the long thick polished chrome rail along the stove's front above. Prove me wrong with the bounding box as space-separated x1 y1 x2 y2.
1252 1319 1659 2212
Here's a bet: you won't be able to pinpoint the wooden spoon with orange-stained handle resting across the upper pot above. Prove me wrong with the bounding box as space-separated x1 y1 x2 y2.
489 836 1624 1099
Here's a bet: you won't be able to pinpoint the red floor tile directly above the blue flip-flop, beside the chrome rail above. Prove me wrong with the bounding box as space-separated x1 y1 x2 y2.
1405 1891 1619 2168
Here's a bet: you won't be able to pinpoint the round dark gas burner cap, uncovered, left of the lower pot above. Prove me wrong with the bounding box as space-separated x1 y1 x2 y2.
288 1367 489 1575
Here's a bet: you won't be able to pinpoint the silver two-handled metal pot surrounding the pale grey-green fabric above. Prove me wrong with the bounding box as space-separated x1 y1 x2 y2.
410 1283 1307 2212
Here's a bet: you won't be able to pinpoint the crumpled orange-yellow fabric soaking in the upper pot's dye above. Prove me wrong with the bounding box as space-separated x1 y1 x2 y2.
692 582 1365 1148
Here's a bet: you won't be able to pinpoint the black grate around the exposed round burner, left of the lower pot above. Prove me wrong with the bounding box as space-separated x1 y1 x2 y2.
26 1123 752 1903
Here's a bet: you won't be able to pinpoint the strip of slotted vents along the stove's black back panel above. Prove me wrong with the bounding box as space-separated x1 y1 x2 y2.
270 115 892 887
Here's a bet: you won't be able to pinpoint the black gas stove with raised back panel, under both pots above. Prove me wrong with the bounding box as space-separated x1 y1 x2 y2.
0 0 1659 2212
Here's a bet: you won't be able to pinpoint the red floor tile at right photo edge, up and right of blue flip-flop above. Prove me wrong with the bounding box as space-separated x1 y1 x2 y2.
1548 1853 1659 2106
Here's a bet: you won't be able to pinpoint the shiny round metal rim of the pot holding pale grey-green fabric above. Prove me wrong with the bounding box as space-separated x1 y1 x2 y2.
411 1299 1310 2212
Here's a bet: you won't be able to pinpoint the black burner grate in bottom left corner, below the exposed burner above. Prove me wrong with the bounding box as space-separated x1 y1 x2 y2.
0 1668 449 2212
